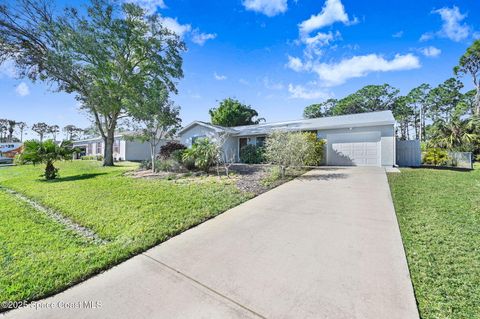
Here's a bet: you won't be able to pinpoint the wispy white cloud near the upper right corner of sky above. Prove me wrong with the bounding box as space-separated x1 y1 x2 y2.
433 6 470 42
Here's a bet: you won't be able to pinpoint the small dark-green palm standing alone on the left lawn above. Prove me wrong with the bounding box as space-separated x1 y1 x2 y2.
20 140 76 180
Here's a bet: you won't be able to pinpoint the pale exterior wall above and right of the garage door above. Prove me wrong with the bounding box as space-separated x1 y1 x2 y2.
317 125 395 166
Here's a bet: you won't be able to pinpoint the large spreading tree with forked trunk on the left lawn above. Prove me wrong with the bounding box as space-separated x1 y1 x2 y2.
0 0 185 166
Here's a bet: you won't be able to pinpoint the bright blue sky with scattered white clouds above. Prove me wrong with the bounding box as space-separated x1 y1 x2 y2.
0 0 480 137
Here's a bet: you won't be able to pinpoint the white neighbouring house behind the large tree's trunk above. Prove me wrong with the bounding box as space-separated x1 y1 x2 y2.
73 132 166 161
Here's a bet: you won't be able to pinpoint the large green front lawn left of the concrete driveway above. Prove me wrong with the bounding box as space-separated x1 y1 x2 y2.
0 161 251 303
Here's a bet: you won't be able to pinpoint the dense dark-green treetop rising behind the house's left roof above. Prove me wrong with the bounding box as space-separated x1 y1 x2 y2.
209 98 264 127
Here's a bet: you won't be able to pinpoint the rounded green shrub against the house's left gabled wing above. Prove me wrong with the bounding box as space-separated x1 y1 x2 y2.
182 138 220 172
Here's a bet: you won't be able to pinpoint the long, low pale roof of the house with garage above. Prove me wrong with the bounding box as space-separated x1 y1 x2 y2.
178 111 395 136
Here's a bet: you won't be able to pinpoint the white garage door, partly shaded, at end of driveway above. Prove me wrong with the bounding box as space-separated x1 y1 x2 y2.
327 132 381 166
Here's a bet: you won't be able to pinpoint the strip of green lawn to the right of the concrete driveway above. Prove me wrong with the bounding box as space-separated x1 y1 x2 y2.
388 166 480 319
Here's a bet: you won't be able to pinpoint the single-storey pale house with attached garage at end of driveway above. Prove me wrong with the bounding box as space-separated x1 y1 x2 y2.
178 111 395 166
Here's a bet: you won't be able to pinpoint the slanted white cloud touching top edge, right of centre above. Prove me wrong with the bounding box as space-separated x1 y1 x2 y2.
299 0 357 36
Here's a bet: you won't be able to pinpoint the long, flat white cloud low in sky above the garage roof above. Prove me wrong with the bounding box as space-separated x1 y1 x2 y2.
287 54 420 86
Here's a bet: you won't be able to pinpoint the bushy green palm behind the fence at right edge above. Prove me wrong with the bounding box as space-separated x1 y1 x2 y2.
430 116 480 150
